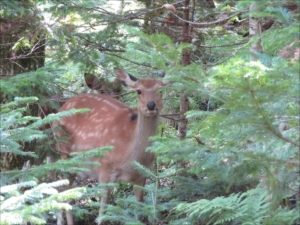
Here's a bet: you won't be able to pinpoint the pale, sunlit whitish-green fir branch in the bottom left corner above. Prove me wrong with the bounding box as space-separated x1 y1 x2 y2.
0 180 85 224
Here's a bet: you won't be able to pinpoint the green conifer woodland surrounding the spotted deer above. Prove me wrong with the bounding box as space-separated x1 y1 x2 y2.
0 0 300 225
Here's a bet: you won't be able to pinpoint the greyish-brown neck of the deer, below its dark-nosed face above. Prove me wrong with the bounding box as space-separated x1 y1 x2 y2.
132 111 158 166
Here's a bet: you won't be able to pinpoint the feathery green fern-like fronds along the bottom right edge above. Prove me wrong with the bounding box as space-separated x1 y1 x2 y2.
176 189 299 225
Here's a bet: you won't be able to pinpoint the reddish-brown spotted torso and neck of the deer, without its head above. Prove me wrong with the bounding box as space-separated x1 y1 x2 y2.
59 94 157 182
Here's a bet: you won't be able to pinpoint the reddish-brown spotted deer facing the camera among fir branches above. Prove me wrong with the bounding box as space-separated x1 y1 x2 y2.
53 68 167 225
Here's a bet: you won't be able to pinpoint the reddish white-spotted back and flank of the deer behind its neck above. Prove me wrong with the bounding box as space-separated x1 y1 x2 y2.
59 94 137 154
